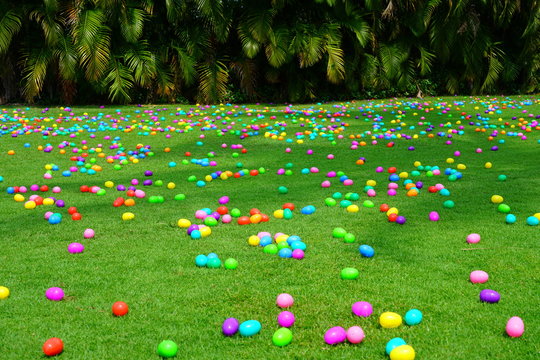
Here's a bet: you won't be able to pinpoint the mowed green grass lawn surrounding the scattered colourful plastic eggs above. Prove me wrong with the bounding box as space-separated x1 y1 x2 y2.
0 96 540 359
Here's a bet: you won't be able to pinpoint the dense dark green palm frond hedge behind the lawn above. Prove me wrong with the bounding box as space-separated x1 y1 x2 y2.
0 0 540 104
